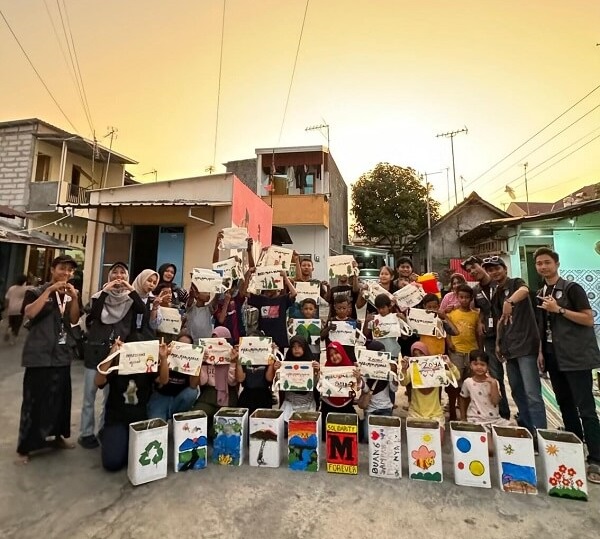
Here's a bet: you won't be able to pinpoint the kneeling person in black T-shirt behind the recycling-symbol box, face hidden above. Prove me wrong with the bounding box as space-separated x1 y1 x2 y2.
95 339 169 472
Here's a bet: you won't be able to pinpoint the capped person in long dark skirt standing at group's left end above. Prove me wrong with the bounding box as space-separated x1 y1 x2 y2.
17 255 80 464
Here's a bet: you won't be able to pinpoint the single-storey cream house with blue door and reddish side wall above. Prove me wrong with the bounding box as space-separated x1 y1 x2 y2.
59 173 272 300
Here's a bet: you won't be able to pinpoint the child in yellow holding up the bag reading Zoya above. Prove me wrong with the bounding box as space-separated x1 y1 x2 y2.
401 341 460 443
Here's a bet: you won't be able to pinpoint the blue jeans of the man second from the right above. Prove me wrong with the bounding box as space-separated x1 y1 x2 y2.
506 356 547 439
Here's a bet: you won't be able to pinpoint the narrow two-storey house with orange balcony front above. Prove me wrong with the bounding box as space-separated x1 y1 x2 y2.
225 146 348 278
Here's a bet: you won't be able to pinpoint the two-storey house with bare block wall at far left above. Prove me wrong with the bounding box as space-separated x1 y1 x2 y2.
0 118 136 286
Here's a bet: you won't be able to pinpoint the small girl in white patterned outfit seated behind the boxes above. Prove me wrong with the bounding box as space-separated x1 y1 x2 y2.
460 350 510 455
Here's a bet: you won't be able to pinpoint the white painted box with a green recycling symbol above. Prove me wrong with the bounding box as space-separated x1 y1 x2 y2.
127 419 169 485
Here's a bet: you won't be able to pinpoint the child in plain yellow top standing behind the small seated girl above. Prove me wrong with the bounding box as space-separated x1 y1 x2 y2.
446 284 483 421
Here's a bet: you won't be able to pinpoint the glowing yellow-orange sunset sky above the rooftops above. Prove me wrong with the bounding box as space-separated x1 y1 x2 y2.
0 0 600 211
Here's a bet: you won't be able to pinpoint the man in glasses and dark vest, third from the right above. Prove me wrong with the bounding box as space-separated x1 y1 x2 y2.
461 256 510 419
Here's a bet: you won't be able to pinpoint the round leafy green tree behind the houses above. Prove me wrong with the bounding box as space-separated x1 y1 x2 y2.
352 163 440 256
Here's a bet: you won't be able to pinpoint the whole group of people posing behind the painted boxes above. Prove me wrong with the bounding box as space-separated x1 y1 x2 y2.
7 233 600 483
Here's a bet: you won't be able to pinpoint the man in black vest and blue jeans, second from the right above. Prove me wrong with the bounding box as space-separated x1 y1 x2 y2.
481 256 547 443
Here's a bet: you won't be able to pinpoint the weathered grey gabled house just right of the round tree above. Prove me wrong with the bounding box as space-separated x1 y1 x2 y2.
412 192 509 273
